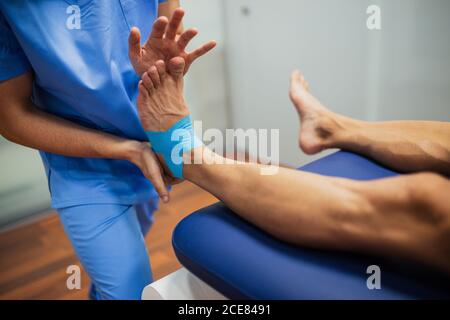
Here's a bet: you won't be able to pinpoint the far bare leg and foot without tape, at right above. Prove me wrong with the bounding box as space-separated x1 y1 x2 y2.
290 72 450 175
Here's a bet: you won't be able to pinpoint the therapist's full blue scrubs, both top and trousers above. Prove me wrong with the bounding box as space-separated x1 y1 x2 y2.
0 0 164 298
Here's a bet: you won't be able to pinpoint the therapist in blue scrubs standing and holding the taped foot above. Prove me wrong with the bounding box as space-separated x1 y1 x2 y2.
0 0 215 299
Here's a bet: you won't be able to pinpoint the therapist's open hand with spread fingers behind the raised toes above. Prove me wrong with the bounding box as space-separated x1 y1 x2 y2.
128 8 216 76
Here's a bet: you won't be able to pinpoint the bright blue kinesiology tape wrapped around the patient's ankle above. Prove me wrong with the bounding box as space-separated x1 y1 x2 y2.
146 116 202 179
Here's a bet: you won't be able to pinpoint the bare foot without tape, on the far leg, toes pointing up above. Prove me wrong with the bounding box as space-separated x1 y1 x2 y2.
289 71 339 154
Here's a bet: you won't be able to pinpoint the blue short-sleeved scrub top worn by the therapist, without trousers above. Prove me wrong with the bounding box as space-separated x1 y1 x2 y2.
0 0 164 208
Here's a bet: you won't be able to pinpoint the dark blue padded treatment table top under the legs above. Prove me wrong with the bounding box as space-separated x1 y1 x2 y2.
172 151 450 299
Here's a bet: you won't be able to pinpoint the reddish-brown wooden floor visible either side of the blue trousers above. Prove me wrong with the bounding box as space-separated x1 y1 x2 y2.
0 182 217 299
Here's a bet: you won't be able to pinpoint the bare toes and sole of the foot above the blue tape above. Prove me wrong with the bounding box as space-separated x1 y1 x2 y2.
137 57 189 131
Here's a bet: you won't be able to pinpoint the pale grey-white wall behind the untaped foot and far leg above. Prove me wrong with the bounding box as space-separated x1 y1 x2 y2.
224 0 450 166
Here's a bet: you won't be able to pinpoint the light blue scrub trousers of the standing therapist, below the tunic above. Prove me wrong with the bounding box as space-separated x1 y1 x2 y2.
58 199 158 299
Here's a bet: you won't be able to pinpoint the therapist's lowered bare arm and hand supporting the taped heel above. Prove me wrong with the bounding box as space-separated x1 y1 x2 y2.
0 72 168 200
